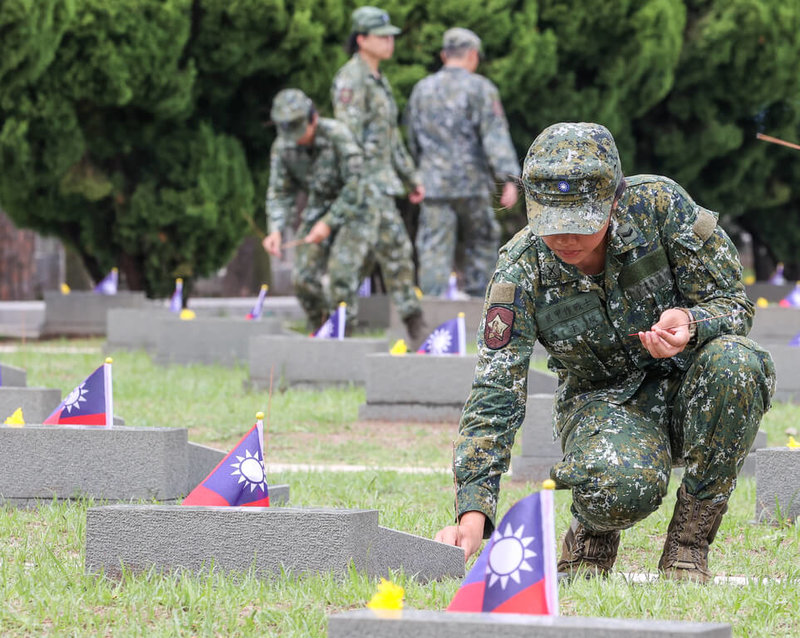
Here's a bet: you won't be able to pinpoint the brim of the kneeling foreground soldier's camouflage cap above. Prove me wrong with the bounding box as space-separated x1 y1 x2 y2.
525 195 614 237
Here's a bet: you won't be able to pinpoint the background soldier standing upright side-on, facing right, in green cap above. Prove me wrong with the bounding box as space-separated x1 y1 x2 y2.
328 7 427 345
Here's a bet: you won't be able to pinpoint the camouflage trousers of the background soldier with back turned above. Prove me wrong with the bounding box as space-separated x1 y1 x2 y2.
416 193 500 297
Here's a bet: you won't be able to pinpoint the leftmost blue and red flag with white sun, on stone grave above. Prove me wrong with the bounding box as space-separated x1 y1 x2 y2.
43 359 114 427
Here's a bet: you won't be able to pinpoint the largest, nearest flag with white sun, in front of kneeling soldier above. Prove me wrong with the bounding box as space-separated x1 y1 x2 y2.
447 489 558 616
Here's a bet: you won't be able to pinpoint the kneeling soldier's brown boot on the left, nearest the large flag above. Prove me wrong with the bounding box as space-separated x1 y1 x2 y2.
558 518 619 578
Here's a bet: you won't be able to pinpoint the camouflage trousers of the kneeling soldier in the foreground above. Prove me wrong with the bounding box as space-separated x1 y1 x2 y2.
551 336 775 532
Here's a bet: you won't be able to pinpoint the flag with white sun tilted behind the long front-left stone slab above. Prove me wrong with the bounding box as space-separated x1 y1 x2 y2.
182 412 269 507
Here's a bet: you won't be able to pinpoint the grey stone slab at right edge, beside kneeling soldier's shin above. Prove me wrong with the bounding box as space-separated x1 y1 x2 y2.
756 447 800 522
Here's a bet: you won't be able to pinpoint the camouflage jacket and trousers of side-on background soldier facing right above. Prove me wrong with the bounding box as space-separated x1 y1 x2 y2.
328 36 420 319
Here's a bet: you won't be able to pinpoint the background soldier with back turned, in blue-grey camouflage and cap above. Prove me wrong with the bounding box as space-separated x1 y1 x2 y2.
405 28 519 297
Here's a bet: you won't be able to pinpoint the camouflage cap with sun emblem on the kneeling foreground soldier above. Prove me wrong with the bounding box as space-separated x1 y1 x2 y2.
522 122 622 236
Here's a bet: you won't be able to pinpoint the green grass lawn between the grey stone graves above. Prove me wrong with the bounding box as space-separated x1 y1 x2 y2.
0 340 800 637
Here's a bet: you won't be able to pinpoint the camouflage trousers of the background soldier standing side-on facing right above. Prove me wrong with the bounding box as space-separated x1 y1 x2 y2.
328 188 421 325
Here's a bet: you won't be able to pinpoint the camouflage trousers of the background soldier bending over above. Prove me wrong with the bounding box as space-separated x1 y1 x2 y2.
292 221 330 330
